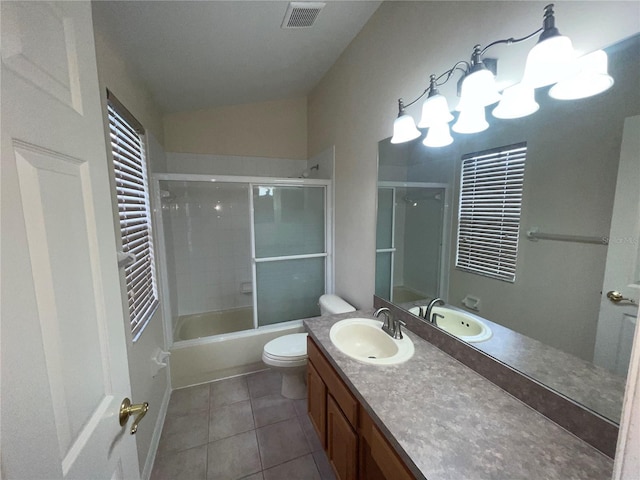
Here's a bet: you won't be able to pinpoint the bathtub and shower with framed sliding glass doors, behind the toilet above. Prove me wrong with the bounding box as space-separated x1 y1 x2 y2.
153 174 332 388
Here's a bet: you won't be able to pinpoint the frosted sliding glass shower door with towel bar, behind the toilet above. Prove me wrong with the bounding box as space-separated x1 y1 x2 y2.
253 185 328 326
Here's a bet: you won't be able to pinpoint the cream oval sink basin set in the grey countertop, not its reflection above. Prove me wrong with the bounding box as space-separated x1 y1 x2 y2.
329 318 414 365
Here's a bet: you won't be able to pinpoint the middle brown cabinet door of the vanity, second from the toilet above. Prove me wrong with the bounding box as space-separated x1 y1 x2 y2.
327 395 358 480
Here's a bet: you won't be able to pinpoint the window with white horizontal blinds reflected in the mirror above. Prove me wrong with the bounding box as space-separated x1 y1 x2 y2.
456 142 527 282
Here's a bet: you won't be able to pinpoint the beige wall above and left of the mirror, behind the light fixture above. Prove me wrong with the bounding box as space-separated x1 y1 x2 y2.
308 1 640 307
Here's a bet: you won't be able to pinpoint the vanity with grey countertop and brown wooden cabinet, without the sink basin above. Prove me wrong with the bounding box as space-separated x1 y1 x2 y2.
304 312 613 480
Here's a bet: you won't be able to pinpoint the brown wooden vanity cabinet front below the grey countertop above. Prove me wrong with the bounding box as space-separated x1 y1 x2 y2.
307 337 415 480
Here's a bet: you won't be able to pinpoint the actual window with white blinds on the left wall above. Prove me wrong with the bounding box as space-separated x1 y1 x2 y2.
107 93 158 341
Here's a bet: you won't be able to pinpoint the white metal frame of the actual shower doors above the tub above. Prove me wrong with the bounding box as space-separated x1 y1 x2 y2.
151 173 335 348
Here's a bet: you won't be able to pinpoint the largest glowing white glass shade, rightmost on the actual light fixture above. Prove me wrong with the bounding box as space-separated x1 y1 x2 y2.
522 35 575 88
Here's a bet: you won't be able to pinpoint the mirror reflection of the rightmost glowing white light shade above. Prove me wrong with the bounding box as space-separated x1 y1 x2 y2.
549 50 613 100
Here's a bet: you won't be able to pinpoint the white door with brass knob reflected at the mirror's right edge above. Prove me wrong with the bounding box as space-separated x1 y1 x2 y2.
594 116 640 375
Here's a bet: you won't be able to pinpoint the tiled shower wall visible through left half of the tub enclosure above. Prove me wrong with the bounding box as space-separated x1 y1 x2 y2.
161 182 252 316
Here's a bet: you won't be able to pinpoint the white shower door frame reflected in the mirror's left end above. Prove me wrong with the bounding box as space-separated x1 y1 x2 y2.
376 181 452 302
